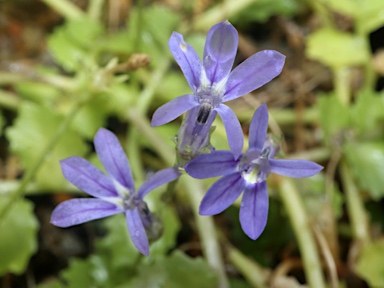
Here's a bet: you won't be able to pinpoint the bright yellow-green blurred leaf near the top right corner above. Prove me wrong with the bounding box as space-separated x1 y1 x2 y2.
306 28 370 68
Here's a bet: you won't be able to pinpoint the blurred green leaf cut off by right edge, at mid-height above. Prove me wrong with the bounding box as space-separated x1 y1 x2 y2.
343 142 384 199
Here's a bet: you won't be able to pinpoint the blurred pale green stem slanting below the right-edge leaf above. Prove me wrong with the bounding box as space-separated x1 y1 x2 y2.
340 162 370 245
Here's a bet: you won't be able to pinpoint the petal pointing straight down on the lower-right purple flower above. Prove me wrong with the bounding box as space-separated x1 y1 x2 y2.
240 181 269 240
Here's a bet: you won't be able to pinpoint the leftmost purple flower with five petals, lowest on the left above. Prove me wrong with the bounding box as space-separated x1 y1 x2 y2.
51 128 180 255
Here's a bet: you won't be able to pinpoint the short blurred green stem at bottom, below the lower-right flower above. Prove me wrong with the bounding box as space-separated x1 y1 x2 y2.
227 246 271 288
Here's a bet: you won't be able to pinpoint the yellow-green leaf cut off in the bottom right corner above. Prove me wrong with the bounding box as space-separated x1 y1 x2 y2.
356 239 384 287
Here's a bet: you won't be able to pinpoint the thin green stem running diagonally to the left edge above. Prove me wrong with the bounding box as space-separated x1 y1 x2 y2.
0 103 82 220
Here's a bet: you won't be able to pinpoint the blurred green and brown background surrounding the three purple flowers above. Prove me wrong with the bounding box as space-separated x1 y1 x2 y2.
0 0 384 288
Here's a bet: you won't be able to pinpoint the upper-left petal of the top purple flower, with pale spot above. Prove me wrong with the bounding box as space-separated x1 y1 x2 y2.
168 32 203 92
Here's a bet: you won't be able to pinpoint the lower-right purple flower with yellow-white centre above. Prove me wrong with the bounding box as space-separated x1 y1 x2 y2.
185 104 323 240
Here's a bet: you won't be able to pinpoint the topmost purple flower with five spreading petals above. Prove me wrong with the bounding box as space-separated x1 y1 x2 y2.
151 21 285 157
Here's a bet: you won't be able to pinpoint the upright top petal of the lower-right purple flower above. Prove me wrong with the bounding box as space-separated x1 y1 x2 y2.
248 103 268 151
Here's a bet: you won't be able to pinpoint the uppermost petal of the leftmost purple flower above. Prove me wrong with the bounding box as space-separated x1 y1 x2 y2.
94 128 135 191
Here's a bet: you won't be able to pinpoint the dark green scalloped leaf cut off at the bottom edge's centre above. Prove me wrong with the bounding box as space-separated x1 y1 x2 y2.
127 250 217 288
